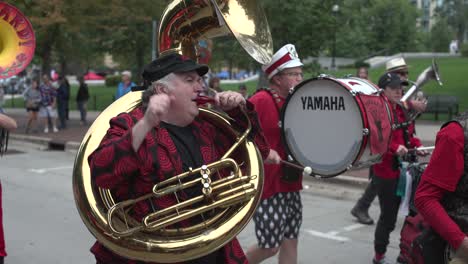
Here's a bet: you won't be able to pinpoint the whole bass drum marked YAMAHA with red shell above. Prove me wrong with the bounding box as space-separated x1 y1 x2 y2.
281 76 393 177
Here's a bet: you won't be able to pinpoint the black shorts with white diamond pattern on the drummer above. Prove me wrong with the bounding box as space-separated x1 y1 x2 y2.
254 192 302 248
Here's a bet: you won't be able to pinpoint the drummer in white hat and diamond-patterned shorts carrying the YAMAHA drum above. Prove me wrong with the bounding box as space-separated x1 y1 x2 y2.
246 44 303 264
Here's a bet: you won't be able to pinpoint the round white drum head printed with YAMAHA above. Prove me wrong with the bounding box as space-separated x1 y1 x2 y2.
281 78 364 177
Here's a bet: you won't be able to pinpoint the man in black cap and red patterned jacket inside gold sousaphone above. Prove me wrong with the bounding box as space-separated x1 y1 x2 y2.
88 54 269 264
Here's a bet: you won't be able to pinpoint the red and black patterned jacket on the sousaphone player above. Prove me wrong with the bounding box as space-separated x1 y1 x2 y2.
88 103 269 264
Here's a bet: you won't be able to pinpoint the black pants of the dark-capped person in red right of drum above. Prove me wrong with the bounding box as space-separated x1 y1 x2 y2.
373 175 401 254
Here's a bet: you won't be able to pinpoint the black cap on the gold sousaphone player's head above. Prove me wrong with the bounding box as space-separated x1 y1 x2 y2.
141 53 208 82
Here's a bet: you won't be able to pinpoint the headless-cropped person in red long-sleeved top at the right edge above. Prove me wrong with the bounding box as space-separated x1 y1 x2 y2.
415 112 468 263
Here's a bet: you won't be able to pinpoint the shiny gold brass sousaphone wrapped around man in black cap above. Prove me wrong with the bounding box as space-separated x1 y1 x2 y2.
73 0 272 263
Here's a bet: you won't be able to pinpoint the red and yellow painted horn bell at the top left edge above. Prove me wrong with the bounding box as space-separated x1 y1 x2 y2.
0 2 36 79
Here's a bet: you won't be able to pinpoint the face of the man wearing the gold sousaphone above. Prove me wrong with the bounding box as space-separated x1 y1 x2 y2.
169 71 204 120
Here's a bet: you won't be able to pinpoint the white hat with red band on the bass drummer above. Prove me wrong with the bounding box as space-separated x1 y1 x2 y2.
262 44 304 79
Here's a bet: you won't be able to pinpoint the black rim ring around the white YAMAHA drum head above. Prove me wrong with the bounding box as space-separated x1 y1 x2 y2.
280 76 375 178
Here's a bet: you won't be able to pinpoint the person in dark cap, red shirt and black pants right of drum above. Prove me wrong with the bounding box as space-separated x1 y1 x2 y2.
371 73 423 264
